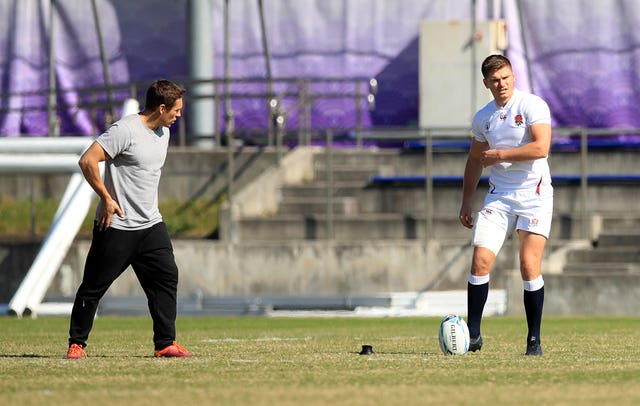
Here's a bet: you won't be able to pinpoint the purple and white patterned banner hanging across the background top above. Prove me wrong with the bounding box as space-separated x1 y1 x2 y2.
0 0 640 136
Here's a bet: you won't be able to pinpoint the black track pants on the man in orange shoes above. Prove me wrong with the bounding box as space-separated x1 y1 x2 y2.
69 223 178 350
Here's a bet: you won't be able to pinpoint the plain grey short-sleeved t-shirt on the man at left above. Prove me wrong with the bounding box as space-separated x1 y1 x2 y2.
96 114 169 230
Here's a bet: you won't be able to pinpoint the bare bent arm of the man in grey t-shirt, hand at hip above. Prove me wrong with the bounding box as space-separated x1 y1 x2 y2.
78 141 124 230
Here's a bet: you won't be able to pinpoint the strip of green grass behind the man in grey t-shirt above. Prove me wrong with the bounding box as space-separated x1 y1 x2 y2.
0 199 222 239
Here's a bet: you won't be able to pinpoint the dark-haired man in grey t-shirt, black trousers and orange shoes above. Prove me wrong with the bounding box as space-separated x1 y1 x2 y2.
67 80 191 359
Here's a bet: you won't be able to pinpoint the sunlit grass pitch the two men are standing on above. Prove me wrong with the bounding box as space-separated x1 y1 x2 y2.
0 317 640 406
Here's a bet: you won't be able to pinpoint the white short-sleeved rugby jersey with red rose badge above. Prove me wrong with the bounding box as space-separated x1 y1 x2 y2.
471 89 553 194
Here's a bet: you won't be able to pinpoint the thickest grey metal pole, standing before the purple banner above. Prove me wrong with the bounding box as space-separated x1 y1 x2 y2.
185 0 218 147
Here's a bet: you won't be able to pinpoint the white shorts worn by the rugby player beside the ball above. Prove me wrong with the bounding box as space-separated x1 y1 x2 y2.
472 192 553 255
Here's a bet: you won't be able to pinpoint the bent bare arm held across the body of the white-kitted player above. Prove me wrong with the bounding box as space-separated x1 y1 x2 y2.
482 123 551 168
